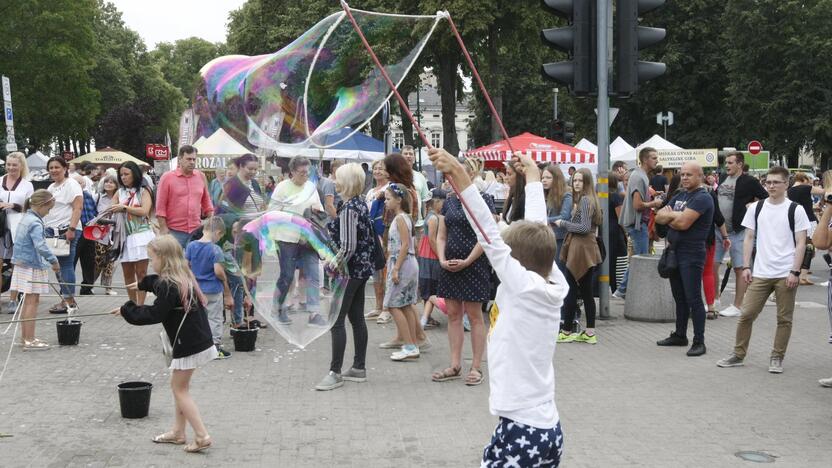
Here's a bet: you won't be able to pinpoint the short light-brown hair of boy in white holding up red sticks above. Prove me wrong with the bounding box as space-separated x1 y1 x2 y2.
503 220 557 278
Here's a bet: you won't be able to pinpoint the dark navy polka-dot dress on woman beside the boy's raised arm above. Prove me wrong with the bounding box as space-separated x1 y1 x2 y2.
436 193 494 302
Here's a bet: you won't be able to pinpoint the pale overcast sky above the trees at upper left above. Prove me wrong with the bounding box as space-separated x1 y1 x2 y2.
108 0 245 50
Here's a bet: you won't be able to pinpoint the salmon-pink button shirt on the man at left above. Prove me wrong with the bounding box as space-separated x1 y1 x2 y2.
156 168 214 232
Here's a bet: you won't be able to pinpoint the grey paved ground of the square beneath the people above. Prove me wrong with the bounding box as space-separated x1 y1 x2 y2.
0 268 832 468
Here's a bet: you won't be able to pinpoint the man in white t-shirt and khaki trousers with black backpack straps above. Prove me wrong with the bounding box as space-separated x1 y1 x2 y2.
717 167 809 374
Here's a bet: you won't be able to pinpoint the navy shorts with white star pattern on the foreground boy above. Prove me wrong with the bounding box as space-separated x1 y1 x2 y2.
480 418 563 468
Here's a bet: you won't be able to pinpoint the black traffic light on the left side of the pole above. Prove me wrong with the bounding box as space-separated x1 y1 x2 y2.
541 0 598 96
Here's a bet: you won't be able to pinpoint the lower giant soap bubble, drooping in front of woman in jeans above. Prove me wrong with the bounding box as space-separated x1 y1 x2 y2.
228 185 348 348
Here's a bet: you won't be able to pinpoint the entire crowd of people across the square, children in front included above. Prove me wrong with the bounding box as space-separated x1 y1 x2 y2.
0 142 832 457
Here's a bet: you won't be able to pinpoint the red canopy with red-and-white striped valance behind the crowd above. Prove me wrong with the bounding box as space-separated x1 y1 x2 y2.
465 132 595 165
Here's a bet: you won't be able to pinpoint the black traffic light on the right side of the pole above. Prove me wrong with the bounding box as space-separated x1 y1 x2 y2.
615 0 667 97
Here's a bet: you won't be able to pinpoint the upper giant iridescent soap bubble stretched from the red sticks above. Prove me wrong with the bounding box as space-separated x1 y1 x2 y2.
193 10 443 152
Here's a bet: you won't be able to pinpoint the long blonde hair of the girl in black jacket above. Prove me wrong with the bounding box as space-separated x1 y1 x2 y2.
147 234 205 313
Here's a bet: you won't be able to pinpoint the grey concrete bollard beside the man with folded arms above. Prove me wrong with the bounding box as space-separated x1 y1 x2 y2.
624 255 676 322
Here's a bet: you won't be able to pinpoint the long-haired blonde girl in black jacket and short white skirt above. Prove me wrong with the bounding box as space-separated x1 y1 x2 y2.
113 235 217 452
